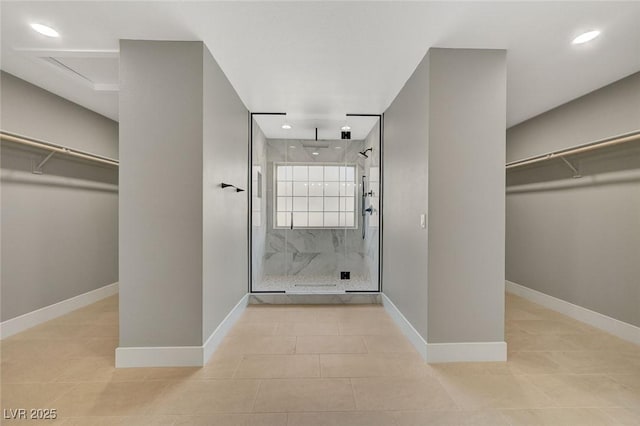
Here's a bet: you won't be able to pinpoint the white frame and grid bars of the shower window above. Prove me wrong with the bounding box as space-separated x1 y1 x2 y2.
272 161 360 229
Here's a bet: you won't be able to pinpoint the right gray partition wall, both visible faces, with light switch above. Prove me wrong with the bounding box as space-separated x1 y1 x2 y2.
383 49 506 343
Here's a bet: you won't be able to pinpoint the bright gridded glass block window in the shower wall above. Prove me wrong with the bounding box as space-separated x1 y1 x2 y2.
274 163 357 228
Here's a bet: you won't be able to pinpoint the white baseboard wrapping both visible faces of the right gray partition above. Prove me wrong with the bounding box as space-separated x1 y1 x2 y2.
382 293 507 363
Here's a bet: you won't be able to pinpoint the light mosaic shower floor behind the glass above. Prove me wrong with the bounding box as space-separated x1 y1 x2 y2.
253 274 378 294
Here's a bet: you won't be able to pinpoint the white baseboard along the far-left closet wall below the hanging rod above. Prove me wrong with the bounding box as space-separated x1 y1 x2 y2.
0 283 118 339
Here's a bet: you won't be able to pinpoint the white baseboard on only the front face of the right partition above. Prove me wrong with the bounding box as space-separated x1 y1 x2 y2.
427 342 507 364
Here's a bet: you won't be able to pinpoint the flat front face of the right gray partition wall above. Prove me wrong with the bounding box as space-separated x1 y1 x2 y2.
428 49 507 343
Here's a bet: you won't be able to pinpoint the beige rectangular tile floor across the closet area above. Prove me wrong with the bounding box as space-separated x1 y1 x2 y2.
1 295 640 426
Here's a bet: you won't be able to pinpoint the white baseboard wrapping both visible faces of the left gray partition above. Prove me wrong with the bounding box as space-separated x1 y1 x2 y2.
116 294 249 368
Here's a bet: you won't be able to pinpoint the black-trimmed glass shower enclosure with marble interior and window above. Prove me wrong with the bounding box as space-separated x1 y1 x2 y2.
250 115 381 294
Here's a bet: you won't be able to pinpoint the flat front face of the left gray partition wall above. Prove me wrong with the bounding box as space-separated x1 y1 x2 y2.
120 40 203 346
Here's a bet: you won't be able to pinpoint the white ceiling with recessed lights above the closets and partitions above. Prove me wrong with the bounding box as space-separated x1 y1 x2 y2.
0 1 640 136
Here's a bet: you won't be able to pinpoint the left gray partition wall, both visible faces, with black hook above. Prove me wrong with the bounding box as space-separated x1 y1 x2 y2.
120 40 248 347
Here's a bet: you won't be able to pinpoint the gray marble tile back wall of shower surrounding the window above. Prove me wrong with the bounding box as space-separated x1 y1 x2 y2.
263 139 370 282
